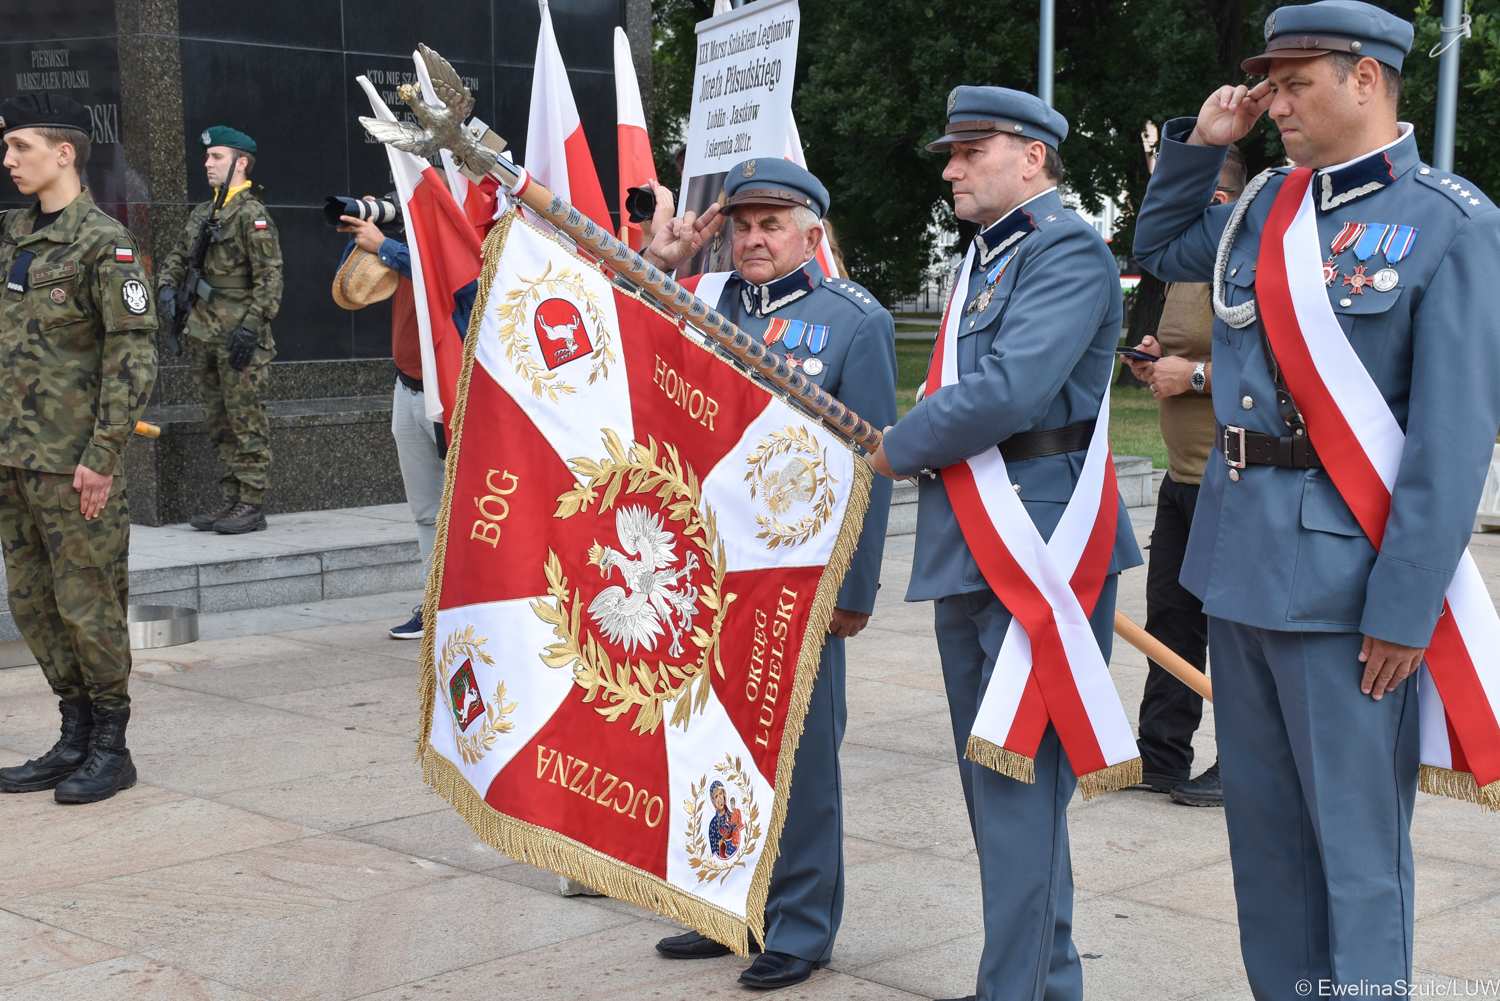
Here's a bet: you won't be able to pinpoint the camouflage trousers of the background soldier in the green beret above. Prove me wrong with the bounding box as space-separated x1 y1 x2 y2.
188 330 276 504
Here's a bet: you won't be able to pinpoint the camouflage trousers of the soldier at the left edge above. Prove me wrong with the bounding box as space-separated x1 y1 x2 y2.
0 465 131 708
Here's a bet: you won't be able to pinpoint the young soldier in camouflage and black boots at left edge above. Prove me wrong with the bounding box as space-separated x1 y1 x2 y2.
0 95 156 803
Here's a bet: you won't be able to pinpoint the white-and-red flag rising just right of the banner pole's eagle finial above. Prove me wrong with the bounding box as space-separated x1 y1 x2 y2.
527 0 614 233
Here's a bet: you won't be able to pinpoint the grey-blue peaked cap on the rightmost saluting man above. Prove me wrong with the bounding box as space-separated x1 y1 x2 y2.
1239 0 1413 74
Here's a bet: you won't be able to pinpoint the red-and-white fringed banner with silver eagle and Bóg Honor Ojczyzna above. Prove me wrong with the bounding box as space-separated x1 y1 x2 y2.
419 213 872 954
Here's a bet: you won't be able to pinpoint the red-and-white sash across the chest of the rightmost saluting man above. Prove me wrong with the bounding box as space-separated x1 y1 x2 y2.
1257 168 1500 809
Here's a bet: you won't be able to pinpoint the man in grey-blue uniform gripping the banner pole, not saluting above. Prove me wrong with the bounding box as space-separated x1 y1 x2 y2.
872 87 1142 1001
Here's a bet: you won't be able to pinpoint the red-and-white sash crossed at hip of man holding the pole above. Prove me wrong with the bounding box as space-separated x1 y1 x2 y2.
926 246 1140 797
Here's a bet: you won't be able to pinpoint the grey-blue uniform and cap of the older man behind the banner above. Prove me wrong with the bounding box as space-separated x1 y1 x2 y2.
663 159 896 966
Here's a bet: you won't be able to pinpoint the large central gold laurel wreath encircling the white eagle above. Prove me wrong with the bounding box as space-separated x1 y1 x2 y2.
531 428 737 734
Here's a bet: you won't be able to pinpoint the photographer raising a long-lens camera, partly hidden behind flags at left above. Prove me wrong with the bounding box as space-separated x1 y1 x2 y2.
334 195 479 639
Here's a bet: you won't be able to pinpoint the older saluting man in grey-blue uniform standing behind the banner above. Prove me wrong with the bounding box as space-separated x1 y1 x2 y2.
645 159 896 987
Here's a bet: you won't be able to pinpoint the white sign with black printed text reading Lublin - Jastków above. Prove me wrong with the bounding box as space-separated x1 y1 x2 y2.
677 0 804 278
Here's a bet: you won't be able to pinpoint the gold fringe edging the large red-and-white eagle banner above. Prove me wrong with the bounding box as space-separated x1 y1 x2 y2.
417 210 873 956
